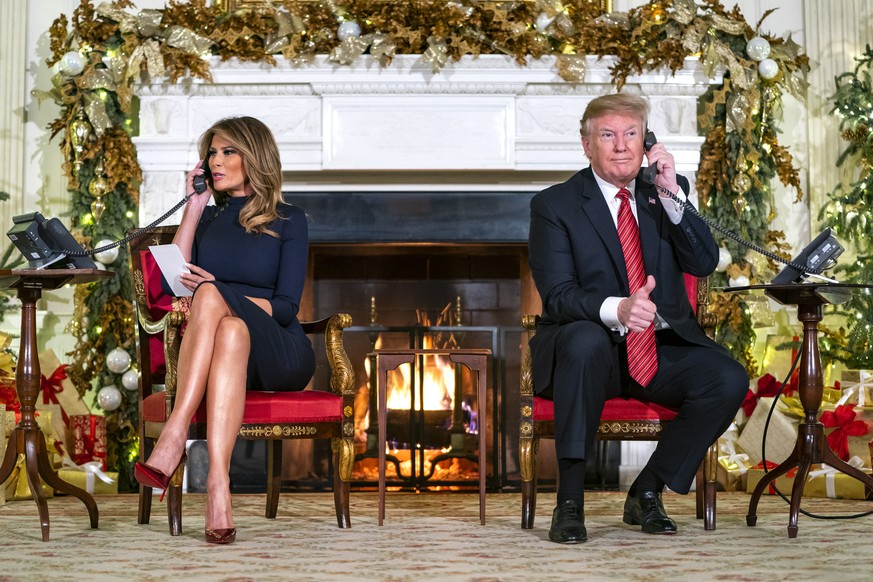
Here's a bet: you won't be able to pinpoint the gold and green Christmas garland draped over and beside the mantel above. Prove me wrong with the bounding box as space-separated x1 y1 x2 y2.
36 0 808 488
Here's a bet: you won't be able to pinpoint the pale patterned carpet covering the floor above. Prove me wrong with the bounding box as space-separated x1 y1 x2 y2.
0 492 873 582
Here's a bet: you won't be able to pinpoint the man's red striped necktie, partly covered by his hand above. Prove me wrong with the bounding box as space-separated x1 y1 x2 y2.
617 188 658 387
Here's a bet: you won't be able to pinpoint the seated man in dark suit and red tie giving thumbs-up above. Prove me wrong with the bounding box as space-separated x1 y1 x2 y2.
529 94 748 543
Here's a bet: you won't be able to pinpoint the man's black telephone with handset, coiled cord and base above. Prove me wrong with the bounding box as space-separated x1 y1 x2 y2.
642 130 844 284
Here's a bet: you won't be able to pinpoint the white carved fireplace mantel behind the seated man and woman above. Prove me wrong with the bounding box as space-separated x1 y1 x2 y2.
134 55 718 224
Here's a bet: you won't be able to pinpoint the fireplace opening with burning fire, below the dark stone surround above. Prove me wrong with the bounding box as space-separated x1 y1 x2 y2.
310 244 527 490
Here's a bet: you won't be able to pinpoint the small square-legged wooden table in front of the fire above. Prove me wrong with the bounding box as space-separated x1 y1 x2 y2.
370 348 491 525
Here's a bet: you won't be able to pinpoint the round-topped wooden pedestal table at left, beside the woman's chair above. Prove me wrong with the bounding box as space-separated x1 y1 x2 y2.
0 269 113 542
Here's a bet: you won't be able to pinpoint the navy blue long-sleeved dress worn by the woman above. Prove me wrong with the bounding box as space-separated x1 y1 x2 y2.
191 197 315 391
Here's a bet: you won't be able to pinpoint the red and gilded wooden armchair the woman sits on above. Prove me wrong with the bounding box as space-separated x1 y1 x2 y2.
130 226 355 535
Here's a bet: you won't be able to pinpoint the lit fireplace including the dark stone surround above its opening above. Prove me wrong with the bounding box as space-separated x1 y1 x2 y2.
291 192 538 489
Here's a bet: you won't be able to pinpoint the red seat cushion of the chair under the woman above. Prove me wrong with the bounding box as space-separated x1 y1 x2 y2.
142 390 343 424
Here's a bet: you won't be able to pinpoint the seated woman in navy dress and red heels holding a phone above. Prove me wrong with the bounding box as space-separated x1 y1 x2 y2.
134 117 315 543
